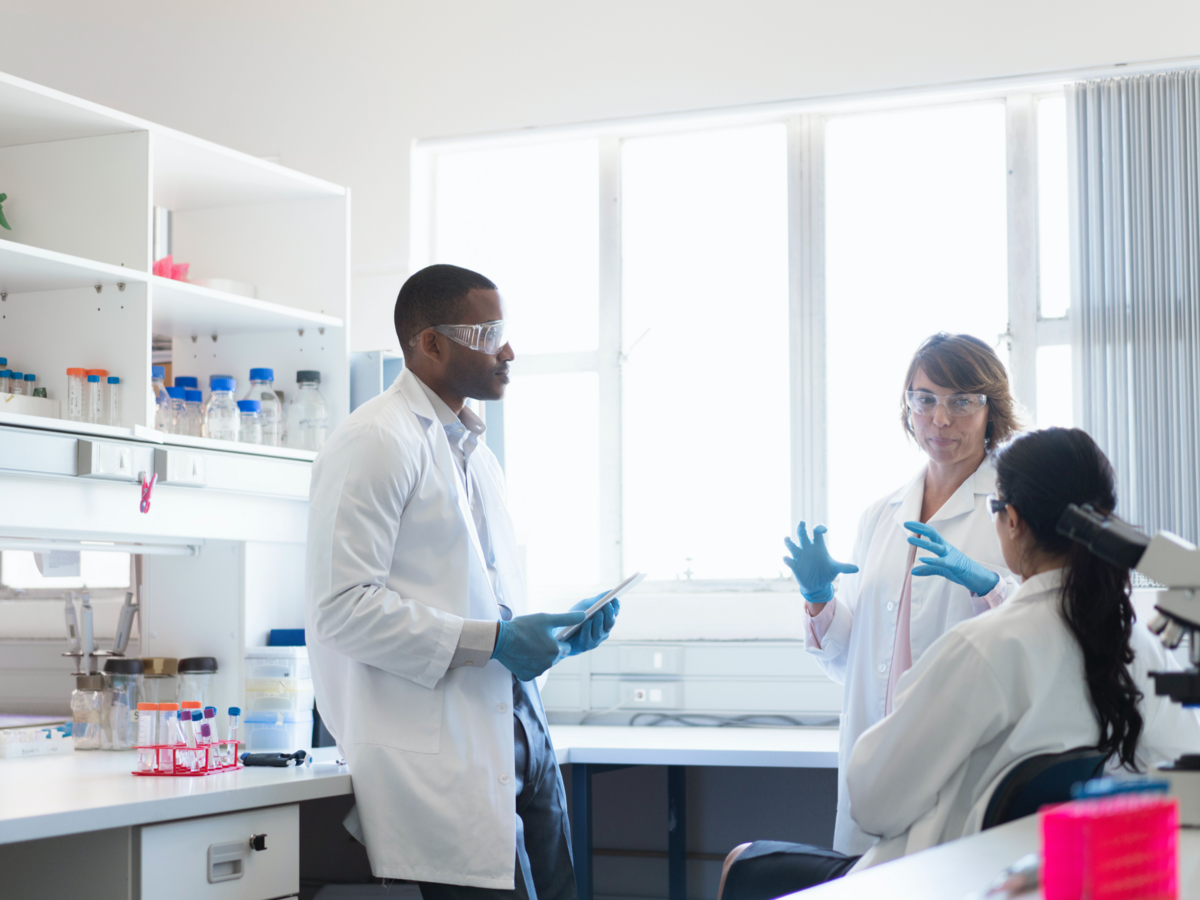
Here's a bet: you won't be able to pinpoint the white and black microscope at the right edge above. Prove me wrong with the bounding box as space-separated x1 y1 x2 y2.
1057 504 1200 826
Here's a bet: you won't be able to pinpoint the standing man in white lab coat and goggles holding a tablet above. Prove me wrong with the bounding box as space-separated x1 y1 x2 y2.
306 265 618 900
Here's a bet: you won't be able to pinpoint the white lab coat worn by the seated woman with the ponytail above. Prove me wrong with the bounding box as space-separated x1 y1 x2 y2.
848 569 1200 868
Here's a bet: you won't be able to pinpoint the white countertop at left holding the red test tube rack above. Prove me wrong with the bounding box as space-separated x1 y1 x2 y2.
0 748 352 844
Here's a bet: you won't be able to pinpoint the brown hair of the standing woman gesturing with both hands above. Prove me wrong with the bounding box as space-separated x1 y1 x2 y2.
900 331 1021 452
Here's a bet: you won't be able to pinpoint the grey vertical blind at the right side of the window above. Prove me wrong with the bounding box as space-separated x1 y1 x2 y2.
1068 71 1200 541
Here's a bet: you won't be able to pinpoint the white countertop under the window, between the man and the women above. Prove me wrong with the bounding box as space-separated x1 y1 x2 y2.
550 725 838 769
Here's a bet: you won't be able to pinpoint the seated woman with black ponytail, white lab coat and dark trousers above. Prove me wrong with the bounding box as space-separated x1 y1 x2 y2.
722 428 1200 900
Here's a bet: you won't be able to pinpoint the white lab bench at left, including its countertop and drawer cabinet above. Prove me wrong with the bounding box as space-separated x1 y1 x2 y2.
0 748 352 900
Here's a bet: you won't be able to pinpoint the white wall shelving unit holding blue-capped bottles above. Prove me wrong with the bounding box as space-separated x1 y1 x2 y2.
0 73 349 448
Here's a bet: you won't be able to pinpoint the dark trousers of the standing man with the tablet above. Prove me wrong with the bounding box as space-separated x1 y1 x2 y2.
421 678 576 900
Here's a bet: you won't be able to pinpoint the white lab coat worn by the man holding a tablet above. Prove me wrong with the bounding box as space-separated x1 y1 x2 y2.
305 370 532 889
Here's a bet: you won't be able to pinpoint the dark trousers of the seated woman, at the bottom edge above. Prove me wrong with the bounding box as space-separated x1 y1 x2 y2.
721 841 859 900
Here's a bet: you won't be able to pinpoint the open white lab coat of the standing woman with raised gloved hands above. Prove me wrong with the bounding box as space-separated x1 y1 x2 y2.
803 458 1016 856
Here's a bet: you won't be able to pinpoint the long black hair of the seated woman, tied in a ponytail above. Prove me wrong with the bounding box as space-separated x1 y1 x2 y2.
996 428 1142 769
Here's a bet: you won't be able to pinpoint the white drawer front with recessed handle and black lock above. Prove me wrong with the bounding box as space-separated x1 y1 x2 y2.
140 804 300 900
